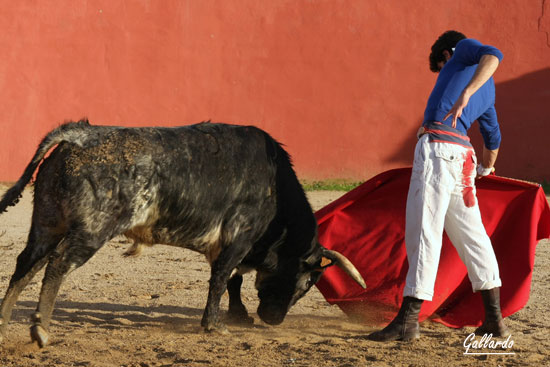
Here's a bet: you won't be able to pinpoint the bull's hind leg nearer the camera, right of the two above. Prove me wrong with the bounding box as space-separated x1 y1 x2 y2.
31 233 105 348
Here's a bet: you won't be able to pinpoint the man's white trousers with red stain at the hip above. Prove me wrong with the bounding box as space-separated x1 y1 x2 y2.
403 134 501 301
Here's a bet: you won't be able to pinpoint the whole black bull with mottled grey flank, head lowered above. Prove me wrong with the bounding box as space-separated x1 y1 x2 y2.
0 120 364 346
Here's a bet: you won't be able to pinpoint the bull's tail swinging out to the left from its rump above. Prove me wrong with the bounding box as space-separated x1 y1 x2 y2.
0 120 90 213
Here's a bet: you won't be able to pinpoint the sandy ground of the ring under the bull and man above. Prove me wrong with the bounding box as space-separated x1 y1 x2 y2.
0 188 550 367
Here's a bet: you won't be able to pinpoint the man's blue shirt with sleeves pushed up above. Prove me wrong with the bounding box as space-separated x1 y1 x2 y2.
424 38 502 150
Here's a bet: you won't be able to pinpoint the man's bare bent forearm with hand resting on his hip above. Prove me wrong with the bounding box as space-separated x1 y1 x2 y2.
443 55 500 129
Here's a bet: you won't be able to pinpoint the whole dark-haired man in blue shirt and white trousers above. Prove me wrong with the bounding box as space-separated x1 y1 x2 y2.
368 31 509 341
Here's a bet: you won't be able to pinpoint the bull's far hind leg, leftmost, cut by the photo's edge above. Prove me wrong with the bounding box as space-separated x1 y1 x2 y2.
0 225 61 341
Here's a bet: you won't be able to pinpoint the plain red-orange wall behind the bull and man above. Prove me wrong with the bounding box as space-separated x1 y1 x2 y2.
0 0 550 181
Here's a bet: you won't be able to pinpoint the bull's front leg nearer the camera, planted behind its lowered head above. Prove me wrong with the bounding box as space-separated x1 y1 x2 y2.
201 242 249 334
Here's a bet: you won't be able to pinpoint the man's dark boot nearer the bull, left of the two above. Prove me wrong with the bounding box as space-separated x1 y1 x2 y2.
367 297 423 342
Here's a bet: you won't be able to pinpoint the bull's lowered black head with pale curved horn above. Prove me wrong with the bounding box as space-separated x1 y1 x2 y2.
256 245 366 325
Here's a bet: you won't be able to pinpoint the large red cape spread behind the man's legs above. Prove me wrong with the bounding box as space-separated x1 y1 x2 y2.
316 168 550 327
